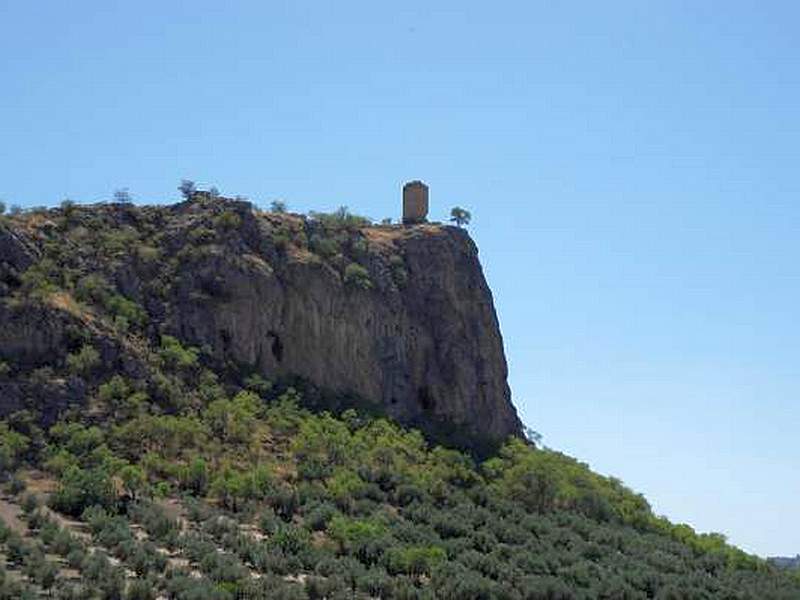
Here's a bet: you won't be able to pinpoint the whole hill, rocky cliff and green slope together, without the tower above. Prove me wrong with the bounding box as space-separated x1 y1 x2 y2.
0 194 800 600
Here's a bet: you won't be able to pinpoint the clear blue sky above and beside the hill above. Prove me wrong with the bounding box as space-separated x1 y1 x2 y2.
0 0 800 554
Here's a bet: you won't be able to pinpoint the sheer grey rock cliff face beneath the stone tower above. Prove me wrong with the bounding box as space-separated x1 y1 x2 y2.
0 195 521 448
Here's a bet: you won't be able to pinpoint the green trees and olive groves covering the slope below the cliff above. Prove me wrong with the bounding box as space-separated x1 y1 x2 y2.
0 376 800 598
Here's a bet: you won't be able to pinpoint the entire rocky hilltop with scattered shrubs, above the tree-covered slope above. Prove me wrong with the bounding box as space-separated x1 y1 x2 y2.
0 193 521 448
